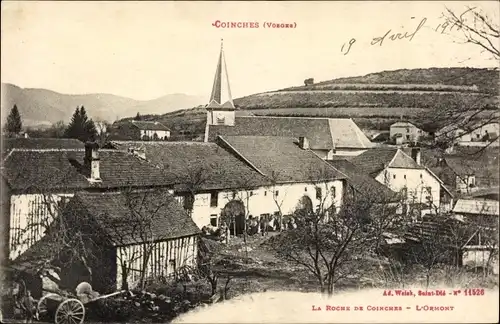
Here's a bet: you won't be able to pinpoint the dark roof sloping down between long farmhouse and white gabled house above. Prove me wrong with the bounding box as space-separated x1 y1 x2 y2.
328 159 398 202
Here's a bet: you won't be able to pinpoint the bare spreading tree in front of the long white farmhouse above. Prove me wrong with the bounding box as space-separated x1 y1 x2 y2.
271 172 396 294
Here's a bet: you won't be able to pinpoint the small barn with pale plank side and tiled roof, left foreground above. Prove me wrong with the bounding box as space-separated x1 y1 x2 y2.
65 190 200 291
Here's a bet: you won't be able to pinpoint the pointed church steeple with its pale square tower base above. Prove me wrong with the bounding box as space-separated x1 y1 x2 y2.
205 39 236 135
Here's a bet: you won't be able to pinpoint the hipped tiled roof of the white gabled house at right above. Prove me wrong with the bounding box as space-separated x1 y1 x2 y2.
351 147 424 176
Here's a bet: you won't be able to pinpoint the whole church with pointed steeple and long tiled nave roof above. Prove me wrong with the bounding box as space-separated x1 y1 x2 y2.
205 39 375 160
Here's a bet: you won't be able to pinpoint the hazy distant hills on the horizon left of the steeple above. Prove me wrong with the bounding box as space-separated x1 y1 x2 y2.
1 83 205 126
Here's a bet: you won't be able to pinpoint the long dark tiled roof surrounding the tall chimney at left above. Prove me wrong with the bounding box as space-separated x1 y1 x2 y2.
2 150 169 190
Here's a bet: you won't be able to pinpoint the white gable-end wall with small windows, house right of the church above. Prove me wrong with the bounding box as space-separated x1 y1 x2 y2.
375 168 441 207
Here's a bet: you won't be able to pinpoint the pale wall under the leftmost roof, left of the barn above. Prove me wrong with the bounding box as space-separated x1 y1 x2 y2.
9 194 73 260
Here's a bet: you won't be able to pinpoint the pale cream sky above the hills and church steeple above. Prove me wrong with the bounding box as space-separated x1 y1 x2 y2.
1 1 500 100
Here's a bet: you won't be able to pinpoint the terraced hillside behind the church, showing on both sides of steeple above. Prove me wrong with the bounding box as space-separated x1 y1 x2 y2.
131 68 499 139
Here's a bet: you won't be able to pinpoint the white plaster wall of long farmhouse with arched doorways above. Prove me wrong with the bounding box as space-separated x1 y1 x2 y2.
188 180 343 228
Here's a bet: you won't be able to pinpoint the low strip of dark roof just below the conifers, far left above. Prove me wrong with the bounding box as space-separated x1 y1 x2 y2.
2 138 85 155
